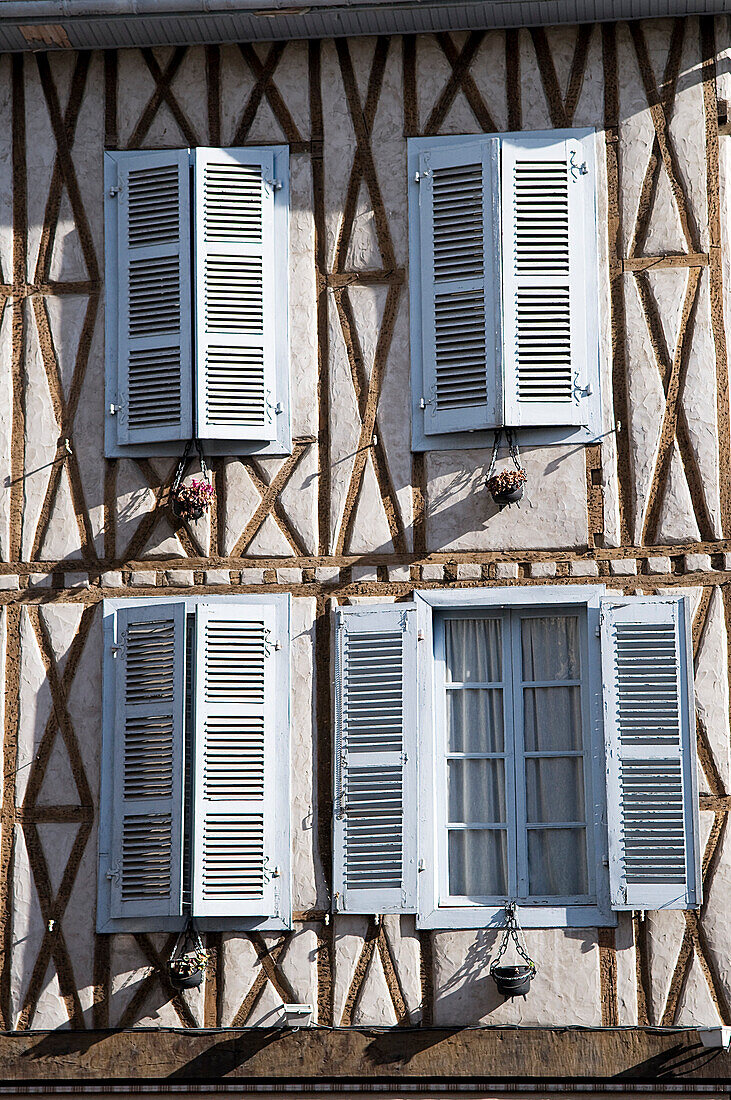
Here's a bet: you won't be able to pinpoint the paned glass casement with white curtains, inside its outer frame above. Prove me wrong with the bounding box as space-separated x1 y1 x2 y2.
434 611 594 904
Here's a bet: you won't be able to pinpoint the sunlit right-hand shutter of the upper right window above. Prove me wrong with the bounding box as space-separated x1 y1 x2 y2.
501 135 598 428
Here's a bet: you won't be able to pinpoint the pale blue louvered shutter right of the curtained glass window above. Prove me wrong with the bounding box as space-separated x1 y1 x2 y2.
601 596 700 910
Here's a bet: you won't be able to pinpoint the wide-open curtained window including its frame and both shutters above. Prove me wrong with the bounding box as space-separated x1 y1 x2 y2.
334 585 700 928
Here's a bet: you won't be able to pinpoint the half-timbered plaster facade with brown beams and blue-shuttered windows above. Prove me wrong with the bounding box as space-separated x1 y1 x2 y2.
0 4 731 1080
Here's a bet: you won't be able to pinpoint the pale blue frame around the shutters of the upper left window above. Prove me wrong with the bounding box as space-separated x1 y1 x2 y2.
104 145 292 459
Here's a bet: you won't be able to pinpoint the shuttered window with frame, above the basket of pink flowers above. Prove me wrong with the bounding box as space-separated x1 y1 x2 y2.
104 146 291 457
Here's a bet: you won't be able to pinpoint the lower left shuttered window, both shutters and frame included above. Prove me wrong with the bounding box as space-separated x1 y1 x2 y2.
97 596 290 932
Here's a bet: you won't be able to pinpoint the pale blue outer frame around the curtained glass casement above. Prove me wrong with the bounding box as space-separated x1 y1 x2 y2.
414 585 617 930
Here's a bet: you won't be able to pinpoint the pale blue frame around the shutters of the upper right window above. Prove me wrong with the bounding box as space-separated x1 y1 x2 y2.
407 128 610 451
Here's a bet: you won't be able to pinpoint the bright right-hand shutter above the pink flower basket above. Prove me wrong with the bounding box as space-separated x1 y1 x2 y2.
196 149 278 440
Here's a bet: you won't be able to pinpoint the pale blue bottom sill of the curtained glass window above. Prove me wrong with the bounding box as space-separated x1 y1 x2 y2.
417 905 617 932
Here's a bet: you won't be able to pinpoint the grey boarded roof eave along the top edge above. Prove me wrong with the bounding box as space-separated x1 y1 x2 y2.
0 0 728 52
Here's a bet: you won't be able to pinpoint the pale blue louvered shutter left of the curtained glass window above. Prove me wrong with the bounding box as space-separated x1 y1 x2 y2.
334 604 417 913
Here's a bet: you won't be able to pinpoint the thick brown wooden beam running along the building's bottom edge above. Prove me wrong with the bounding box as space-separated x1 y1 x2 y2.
0 1029 731 1082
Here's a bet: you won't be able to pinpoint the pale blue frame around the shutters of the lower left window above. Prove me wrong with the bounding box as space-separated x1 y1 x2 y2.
97 594 291 933
